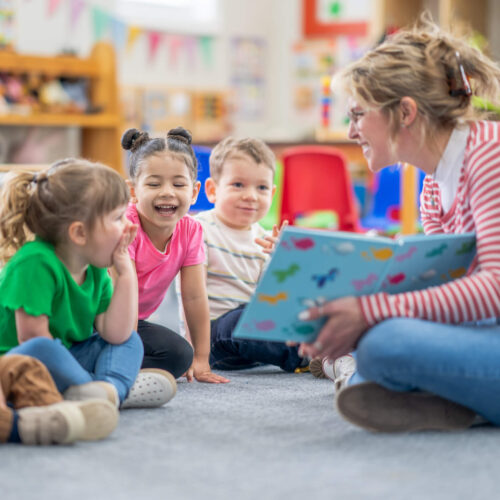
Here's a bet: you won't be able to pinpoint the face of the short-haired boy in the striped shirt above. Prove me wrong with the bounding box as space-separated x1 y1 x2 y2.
205 154 276 230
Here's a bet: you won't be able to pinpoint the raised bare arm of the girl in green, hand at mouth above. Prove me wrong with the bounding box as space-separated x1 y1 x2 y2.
95 223 139 344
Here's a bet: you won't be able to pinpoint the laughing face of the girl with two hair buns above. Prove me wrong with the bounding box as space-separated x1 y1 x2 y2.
130 151 200 240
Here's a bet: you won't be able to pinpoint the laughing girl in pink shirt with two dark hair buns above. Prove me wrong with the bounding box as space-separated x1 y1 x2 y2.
122 127 228 383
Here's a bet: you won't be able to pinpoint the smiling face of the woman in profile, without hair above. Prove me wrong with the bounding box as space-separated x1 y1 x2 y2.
348 98 397 172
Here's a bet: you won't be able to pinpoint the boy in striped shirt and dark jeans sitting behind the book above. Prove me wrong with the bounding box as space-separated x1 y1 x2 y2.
196 137 307 372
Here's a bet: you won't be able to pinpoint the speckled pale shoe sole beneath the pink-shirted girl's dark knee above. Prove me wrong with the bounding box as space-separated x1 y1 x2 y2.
121 368 177 409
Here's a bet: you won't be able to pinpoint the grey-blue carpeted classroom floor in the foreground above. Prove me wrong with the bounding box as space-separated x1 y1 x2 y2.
0 288 500 500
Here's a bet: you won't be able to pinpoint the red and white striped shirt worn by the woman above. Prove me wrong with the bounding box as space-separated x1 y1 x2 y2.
360 121 500 325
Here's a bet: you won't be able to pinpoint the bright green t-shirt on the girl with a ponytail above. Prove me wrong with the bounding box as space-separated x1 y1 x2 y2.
0 238 113 355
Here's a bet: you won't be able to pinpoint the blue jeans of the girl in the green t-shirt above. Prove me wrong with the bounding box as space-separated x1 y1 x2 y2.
7 332 143 401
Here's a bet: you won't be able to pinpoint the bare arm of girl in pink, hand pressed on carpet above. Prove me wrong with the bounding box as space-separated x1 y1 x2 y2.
181 264 229 384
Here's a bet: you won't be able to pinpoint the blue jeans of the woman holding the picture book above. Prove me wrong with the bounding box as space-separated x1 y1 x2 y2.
349 318 500 425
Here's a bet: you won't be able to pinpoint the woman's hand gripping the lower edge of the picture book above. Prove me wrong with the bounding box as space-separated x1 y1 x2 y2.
299 297 368 359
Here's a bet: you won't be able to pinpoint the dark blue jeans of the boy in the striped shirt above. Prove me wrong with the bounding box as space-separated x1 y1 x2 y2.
210 305 302 372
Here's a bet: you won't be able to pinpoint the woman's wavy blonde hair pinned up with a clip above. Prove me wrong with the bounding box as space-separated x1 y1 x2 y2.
334 13 500 145
